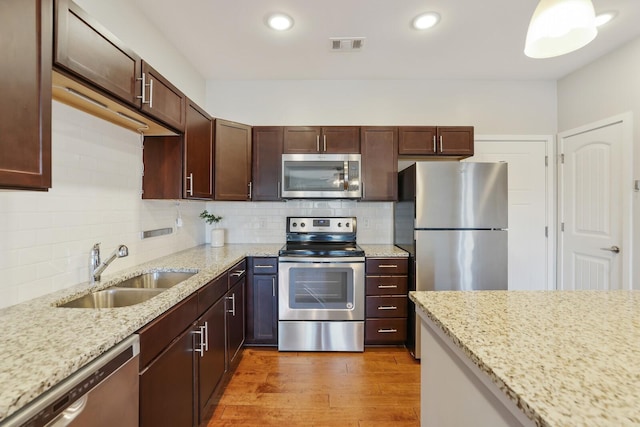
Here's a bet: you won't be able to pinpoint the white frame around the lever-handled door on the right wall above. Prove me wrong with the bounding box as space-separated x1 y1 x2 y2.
556 111 634 289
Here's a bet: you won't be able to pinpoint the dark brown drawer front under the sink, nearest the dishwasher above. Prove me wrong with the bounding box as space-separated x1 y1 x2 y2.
138 293 198 370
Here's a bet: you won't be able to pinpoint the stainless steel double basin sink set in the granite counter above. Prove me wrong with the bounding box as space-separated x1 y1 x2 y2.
58 271 196 308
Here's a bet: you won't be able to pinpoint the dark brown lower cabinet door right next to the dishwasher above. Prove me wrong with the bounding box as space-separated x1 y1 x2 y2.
140 328 194 427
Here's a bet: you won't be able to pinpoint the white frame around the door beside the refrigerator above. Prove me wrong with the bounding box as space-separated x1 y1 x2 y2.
474 135 558 290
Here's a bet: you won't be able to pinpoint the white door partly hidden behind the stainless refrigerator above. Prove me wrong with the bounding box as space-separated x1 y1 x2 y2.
465 136 555 290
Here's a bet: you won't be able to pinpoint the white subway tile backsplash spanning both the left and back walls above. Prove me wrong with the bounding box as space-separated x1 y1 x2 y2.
0 101 393 308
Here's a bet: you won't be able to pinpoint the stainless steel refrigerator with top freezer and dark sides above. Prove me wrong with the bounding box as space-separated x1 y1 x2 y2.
394 162 507 359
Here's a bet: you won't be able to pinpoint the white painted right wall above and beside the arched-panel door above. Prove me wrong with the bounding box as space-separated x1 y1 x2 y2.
558 38 640 287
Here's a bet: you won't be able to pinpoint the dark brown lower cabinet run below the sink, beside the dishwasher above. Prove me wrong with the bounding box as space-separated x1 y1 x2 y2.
138 261 246 427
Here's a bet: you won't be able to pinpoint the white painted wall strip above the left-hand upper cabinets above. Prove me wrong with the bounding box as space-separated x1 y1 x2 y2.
74 0 206 108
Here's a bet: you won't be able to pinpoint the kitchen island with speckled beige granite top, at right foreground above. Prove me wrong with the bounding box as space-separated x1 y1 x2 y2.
410 291 640 426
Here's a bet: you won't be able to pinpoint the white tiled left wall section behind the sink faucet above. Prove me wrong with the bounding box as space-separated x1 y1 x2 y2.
0 102 205 307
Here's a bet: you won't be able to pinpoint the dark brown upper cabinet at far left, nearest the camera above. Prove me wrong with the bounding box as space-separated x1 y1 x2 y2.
0 0 53 190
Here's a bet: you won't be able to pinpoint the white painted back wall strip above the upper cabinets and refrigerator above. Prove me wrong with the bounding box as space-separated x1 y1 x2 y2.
207 80 556 135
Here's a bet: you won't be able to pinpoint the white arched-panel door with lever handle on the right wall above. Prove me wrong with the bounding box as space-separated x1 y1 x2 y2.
558 116 631 290
